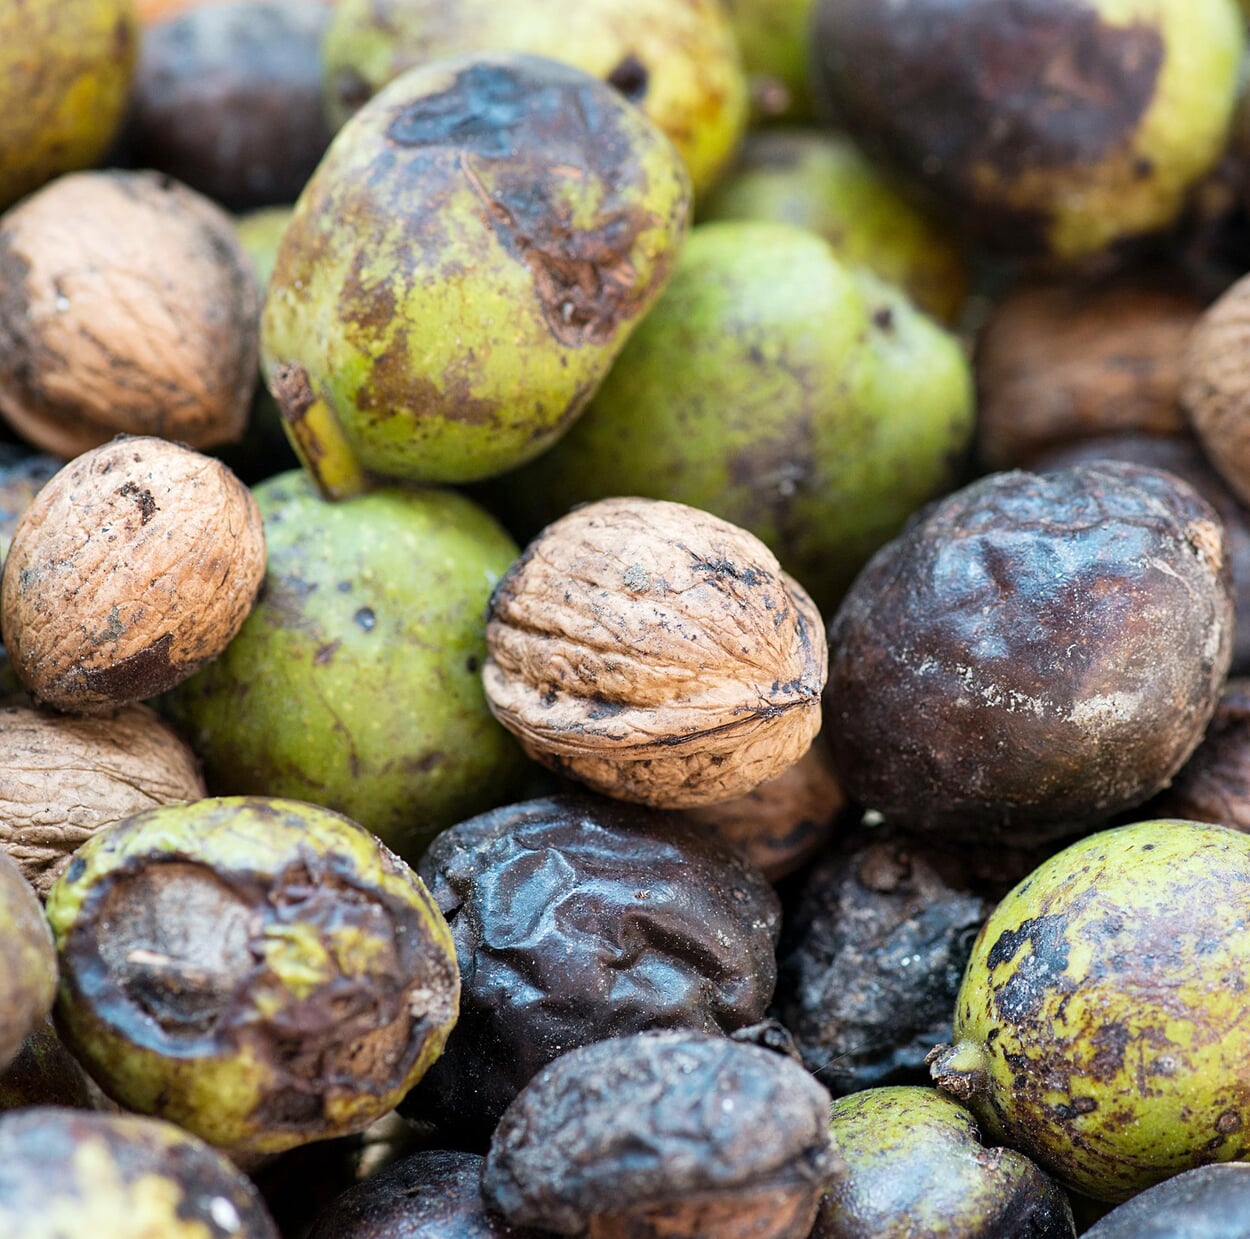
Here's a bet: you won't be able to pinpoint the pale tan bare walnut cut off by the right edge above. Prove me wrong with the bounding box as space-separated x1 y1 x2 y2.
1181 268 1250 503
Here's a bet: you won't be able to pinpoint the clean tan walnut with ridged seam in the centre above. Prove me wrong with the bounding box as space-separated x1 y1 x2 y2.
483 499 828 809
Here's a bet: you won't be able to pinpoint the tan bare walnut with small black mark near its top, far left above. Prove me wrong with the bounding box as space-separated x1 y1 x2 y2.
0 436 265 714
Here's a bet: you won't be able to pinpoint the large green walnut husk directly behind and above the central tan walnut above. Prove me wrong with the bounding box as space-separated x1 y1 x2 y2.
500 220 973 614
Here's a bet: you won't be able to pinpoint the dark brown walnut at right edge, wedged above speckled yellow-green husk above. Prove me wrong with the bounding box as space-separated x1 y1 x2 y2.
1150 679 1250 831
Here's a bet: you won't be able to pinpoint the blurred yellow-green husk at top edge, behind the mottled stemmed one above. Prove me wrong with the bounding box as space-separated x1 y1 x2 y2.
323 0 750 195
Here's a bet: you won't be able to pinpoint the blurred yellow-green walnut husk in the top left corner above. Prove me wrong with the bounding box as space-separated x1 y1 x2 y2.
0 0 139 210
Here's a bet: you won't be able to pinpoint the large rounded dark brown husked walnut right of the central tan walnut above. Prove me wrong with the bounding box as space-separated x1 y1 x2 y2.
826 461 1233 844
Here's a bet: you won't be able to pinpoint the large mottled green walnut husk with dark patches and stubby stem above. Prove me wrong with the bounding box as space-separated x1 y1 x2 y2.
261 53 690 498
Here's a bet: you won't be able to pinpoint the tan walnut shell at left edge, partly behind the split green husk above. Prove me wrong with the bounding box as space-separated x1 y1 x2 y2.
0 701 206 898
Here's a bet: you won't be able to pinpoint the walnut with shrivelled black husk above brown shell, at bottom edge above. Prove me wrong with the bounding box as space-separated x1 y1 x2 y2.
483 1031 839 1239
